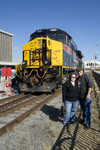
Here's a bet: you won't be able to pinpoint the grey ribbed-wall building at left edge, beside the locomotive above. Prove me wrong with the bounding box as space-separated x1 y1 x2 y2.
0 30 13 62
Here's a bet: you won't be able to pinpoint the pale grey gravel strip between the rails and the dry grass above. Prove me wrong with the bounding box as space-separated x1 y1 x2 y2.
0 95 63 150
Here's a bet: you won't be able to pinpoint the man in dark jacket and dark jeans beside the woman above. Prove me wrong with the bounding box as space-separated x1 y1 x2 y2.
78 69 92 129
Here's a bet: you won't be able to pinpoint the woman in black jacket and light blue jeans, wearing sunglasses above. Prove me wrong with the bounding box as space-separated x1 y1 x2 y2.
63 73 78 125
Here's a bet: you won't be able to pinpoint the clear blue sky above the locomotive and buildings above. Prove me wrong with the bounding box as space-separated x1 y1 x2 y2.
0 0 100 62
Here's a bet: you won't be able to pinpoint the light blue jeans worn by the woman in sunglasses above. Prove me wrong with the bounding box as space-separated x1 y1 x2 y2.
63 100 78 124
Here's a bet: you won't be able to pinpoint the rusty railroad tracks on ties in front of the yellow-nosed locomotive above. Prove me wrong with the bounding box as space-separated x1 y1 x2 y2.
0 88 61 136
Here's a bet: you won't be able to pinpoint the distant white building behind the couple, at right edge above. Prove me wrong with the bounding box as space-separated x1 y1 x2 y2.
84 60 100 70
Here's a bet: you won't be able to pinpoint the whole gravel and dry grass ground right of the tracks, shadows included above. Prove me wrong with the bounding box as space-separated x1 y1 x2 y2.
0 88 100 150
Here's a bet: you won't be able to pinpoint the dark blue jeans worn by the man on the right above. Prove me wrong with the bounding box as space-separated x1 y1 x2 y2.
80 95 92 126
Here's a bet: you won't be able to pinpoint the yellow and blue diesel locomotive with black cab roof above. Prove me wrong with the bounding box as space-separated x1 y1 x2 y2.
16 28 83 92
